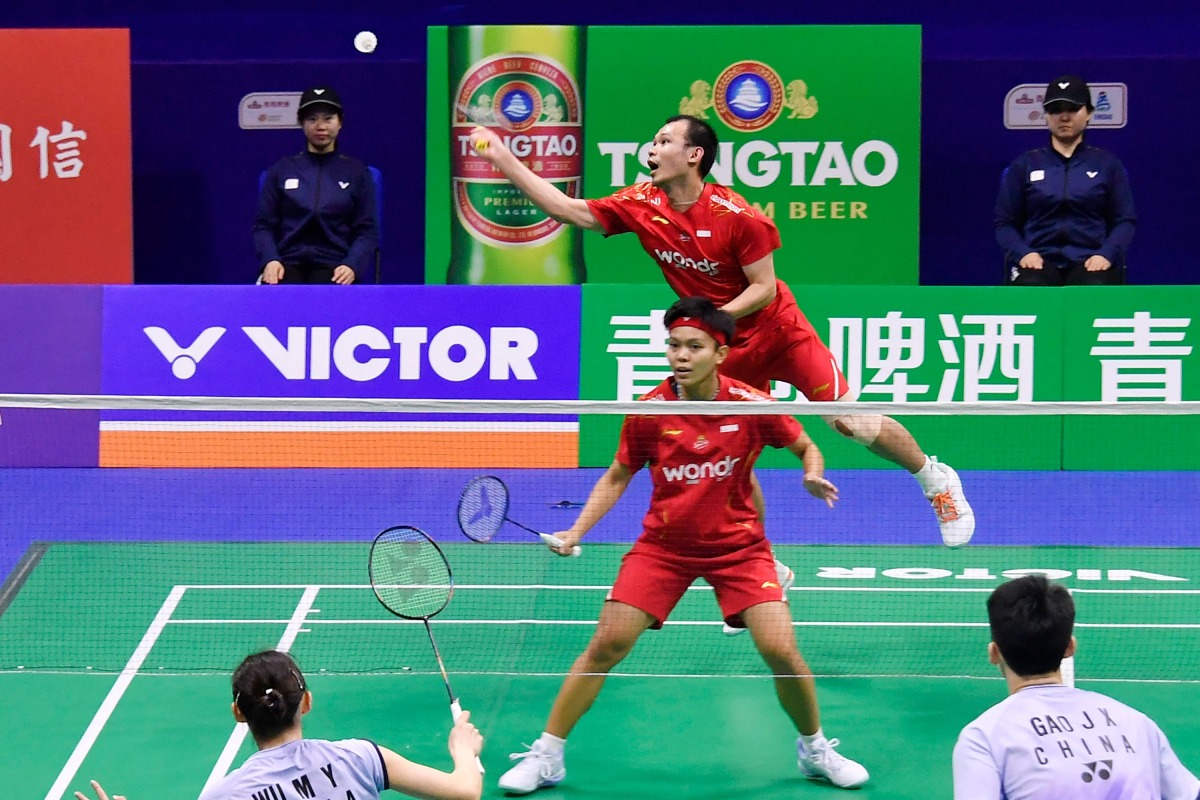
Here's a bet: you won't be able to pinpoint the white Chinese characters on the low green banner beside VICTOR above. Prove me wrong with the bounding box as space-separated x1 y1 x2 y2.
607 309 1192 403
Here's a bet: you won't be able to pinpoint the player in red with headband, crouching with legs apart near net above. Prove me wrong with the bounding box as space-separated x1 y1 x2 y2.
499 297 868 794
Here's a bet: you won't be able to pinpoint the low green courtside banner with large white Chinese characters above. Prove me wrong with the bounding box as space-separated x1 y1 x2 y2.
580 285 1200 470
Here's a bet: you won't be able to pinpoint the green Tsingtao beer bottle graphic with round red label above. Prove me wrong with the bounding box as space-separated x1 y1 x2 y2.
446 25 584 284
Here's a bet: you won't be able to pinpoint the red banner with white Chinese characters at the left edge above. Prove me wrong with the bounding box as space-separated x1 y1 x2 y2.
0 29 133 283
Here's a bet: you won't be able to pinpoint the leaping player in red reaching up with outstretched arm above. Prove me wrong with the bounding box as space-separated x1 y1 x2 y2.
470 115 974 547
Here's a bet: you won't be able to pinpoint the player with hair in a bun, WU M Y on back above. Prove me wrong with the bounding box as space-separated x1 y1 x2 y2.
200 650 484 800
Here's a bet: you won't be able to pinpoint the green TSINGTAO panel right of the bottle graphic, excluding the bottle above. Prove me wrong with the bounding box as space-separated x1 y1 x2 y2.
583 25 920 285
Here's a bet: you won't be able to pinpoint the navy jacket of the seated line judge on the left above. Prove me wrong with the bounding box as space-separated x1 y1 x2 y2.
254 150 379 283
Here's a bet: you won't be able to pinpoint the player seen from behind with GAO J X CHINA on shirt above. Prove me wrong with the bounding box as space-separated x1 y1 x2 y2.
954 575 1200 800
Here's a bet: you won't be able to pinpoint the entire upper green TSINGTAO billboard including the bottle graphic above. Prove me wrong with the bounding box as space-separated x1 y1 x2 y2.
425 25 920 285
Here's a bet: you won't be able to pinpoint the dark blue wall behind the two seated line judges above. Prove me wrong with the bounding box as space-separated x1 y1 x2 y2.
0 0 1200 284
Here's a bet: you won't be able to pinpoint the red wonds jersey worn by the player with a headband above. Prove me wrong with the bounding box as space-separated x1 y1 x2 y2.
617 375 804 554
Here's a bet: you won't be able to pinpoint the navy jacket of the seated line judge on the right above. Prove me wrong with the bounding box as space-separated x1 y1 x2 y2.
996 142 1138 267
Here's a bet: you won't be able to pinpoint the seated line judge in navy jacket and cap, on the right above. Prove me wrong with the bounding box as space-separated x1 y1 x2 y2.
996 76 1138 287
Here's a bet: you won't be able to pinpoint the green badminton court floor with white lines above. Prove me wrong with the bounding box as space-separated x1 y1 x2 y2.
0 542 1200 800
